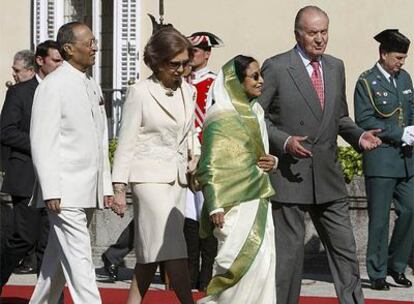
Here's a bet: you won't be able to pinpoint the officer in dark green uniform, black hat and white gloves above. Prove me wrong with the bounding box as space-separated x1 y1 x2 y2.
354 29 414 290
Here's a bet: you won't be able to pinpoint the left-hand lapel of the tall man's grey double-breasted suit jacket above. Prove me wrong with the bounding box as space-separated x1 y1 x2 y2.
288 49 322 120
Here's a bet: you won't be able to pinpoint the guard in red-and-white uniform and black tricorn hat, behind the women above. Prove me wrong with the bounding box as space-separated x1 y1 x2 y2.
184 32 223 290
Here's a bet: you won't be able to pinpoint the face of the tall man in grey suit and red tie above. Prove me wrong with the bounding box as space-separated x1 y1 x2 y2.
295 10 329 60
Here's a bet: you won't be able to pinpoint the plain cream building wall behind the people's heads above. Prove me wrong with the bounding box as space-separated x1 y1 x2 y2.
142 0 414 128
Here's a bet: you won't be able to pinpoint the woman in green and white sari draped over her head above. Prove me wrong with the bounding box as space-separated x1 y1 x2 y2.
198 55 277 304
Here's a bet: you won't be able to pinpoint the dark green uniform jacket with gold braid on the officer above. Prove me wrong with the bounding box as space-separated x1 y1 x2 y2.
354 65 414 178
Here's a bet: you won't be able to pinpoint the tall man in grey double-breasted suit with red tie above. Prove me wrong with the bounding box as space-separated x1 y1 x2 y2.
259 6 380 304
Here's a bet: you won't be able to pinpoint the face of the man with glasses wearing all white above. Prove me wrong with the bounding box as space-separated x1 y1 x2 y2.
69 25 98 72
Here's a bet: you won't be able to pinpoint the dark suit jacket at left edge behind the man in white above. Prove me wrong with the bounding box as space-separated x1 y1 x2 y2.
0 77 39 197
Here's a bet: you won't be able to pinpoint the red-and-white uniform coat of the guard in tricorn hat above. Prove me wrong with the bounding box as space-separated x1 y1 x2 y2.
188 67 216 142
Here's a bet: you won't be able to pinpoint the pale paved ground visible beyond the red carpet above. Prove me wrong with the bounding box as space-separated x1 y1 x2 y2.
4 268 414 304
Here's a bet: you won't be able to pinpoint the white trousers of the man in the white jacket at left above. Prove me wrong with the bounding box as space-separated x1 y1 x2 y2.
29 208 102 304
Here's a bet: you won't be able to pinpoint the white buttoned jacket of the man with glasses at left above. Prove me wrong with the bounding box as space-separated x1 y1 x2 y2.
30 62 113 208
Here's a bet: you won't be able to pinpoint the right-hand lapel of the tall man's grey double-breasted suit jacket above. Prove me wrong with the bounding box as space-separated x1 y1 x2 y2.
315 55 342 141
